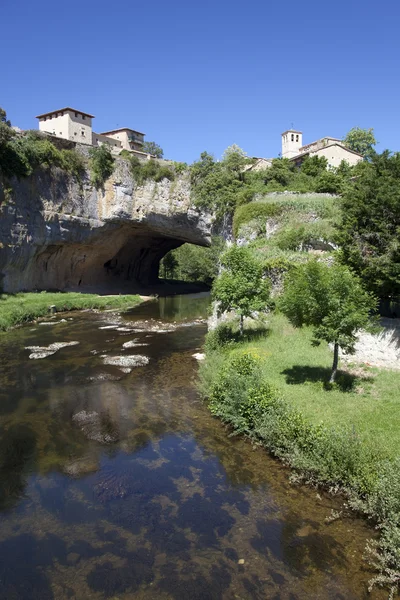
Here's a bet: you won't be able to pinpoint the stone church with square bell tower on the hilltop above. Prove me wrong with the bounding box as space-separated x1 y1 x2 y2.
282 129 363 167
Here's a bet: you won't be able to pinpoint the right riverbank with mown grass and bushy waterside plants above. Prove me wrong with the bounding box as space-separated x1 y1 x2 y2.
200 314 400 592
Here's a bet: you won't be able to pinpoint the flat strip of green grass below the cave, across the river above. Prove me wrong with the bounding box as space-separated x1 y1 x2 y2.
0 292 141 331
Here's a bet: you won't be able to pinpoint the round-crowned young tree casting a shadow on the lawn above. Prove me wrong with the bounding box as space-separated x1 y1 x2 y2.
280 260 377 383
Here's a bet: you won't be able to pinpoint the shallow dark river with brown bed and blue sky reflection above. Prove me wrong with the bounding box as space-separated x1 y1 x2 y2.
0 294 386 600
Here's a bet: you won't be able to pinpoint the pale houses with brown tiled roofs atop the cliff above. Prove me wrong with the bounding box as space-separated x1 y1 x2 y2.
36 107 151 158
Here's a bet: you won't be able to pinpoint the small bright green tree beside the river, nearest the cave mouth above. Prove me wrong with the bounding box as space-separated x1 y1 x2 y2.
212 246 270 335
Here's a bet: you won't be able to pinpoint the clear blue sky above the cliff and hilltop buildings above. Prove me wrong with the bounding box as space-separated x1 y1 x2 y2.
0 0 400 162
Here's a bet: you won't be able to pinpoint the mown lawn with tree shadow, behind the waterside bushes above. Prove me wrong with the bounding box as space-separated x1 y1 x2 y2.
227 314 400 458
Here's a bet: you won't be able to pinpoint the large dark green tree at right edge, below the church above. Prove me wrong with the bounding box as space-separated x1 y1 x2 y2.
338 150 400 298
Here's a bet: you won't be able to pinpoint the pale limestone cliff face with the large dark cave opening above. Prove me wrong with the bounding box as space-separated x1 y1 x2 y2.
0 160 211 292
